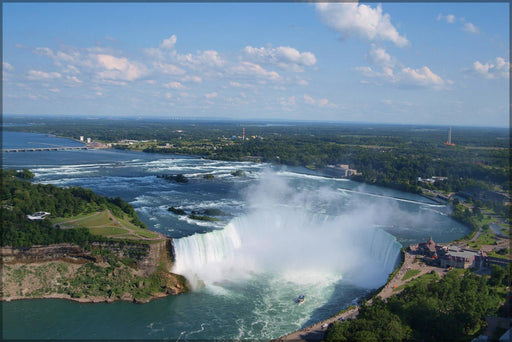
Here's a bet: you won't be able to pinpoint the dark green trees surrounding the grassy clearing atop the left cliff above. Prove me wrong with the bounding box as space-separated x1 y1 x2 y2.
0 170 146 247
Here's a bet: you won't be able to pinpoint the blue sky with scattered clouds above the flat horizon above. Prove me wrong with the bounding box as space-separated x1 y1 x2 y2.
3 2 510 127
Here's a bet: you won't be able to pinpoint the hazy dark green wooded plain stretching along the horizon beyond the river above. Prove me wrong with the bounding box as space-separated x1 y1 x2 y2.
9 118 510 192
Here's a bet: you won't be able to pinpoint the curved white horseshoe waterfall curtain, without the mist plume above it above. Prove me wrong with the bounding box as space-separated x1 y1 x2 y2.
173 210 401 288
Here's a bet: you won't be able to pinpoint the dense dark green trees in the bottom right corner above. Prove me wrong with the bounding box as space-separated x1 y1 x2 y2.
325 270 511 341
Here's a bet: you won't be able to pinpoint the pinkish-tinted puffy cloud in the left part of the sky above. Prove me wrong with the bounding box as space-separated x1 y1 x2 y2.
94 54 147 81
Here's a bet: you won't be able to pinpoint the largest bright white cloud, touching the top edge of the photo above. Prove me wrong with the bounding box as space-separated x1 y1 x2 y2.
316 3 409 47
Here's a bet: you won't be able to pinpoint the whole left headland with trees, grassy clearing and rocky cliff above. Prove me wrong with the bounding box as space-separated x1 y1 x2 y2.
0 170 188 303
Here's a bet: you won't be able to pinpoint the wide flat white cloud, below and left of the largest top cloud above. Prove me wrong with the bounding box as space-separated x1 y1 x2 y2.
243 46 316 71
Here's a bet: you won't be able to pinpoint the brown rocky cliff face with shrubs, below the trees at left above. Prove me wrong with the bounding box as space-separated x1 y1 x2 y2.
0 239 189 303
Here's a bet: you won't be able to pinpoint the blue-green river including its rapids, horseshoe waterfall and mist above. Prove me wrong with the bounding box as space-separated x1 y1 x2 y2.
2 132 467 340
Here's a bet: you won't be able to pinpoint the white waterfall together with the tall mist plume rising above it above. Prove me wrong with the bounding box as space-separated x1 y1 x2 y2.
173 171 401 288
